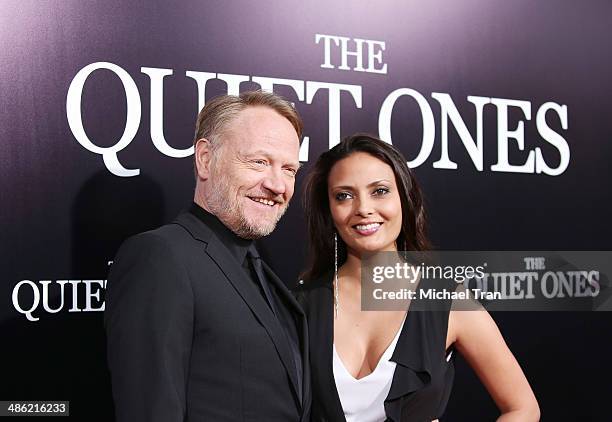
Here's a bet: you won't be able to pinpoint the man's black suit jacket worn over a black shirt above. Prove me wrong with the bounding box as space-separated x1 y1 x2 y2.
105 213 310 422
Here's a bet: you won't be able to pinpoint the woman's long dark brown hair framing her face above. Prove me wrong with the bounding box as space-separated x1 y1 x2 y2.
302 133 430 280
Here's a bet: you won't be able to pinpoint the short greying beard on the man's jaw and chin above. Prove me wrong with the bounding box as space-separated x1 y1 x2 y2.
206 171 288 239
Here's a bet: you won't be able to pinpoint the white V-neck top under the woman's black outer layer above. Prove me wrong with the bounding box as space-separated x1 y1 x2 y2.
333 318 406 422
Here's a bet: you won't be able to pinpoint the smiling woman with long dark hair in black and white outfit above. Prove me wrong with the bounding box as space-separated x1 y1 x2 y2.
297 134 539 422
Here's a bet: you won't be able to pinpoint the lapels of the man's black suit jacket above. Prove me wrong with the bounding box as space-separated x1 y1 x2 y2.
175 213 304 408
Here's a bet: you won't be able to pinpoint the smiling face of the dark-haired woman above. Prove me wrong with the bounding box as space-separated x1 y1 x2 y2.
327 152 402 256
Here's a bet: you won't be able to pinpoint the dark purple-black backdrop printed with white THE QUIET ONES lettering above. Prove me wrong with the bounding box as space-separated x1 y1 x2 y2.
0 0 612 421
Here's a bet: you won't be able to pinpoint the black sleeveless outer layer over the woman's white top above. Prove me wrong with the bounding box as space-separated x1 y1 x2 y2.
295 273 456 422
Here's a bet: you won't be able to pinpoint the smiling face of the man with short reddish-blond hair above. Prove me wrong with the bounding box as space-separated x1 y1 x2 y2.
206 107 300 239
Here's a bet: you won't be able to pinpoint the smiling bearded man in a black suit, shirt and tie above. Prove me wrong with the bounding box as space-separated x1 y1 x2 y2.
105 91 310 422
